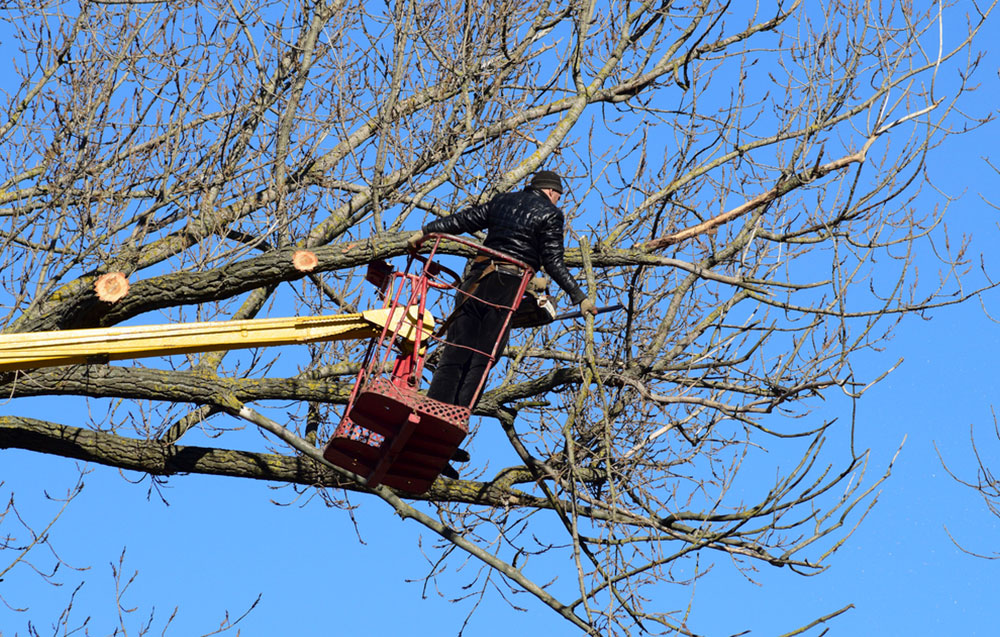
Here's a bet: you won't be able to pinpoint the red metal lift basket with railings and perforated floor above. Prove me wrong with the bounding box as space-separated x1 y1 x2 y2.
323 234 534 493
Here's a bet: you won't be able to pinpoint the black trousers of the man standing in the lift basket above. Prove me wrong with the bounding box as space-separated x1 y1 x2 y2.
427 270 521 409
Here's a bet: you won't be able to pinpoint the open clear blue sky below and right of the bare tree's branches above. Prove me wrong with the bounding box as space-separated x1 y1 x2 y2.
0 2 1000 636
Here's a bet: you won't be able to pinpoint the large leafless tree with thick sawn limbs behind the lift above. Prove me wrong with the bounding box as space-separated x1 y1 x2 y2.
0 0 995 634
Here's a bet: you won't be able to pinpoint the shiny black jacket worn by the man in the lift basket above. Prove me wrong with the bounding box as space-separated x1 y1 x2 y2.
423 188 587 304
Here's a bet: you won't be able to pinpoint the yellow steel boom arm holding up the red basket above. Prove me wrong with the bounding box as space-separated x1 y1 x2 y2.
0 306 434 371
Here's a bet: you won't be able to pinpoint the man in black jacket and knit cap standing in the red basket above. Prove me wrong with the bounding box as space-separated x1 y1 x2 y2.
407 170 596 477
